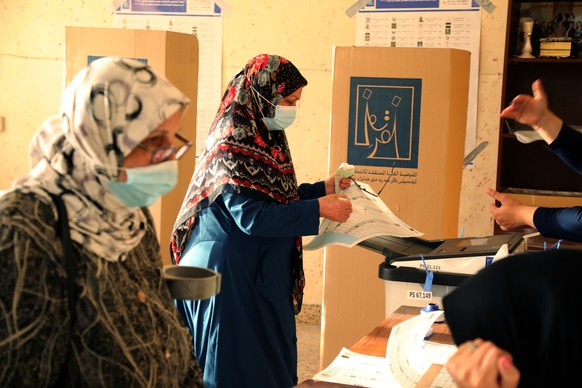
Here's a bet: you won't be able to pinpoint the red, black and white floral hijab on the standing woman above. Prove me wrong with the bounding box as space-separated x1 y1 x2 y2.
170 54 307 312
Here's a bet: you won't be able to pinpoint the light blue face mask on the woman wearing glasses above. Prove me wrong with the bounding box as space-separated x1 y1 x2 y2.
109 160 178 207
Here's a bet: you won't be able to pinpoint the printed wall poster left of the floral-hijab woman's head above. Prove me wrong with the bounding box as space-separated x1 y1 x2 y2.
114 0 222 156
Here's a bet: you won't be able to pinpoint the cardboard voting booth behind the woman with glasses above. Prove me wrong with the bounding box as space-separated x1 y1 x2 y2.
65 27 198 264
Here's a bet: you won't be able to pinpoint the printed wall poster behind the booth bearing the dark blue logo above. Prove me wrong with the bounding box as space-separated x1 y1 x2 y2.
356 0 481 158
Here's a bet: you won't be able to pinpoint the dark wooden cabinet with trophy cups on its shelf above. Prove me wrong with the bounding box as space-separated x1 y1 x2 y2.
497 0 582 206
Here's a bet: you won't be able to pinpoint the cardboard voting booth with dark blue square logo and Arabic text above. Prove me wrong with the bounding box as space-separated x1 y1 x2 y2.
322 46 470 366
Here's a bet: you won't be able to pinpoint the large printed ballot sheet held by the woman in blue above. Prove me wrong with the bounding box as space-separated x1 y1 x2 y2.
303 182 423 250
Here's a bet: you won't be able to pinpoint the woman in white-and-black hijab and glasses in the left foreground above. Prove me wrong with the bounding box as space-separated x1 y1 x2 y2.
0 58 201 387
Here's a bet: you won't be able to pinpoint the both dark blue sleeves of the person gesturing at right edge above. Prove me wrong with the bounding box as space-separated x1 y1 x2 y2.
534 124 582 242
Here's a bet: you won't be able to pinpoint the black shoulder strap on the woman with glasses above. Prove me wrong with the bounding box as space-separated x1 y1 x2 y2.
51 194 78 387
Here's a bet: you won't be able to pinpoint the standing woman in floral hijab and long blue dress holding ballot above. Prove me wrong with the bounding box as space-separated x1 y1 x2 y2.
171 54 351 388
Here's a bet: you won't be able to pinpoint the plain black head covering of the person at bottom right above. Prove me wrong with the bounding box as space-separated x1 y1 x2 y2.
443 249 582 387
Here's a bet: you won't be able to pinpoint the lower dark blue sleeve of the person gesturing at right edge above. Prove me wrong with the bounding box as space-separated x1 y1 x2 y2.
534 206 582 242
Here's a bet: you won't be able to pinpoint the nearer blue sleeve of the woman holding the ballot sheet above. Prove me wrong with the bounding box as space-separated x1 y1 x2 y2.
222 192 319 237
